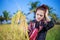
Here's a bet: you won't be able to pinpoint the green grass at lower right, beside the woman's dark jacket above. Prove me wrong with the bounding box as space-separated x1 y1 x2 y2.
46 25 60 40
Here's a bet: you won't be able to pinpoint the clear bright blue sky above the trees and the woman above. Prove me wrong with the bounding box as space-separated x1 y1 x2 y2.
0 0 60 19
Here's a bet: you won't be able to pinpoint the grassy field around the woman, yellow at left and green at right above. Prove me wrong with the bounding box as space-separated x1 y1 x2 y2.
0 24 60 40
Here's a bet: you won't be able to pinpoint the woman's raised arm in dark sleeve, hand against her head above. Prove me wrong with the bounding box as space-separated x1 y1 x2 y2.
45 10 55 30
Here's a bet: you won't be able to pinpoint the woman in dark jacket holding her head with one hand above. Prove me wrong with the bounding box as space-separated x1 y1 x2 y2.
28 5 54 40
